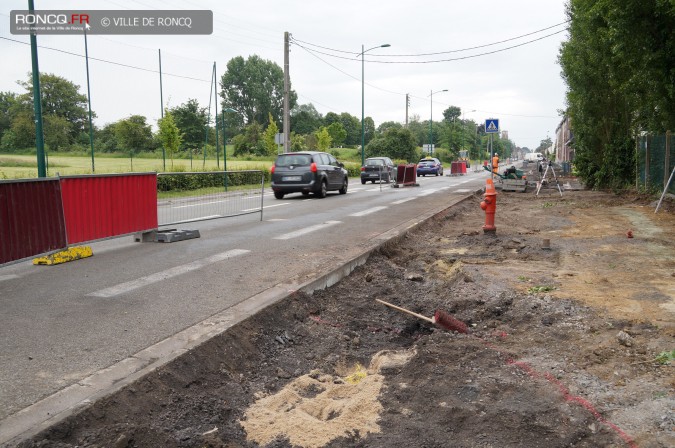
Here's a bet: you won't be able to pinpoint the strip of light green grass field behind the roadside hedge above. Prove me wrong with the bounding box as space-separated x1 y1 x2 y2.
0 154 274 179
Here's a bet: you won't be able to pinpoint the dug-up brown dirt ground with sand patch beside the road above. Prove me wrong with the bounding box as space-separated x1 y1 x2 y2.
15 186 675 448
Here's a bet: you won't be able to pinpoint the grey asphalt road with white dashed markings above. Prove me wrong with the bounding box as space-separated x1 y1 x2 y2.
0 172 489 443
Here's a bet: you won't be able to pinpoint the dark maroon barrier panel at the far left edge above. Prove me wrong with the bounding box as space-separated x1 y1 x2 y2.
0 179 66 264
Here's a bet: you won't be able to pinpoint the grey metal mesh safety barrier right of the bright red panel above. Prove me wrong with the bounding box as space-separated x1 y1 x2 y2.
157 170 265 226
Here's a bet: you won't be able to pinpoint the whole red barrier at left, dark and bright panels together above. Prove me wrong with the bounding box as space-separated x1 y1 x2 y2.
0 173 157 265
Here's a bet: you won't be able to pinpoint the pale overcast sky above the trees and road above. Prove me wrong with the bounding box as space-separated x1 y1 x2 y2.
0 0 568 149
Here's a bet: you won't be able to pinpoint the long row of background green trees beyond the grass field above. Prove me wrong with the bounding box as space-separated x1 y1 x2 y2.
0 55 515 161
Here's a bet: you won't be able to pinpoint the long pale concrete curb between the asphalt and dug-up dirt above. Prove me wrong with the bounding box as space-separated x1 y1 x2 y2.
0 189 482 447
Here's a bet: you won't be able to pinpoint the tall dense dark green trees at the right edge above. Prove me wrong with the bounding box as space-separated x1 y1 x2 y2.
559 0 675 188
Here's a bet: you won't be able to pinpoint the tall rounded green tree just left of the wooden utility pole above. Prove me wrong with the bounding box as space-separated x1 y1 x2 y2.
220 55 298 124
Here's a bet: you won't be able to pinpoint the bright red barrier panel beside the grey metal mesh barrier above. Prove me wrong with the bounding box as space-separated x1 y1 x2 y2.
61 173 157 244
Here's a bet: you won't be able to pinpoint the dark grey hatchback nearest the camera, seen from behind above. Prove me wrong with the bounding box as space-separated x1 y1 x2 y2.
270 151 348 199
